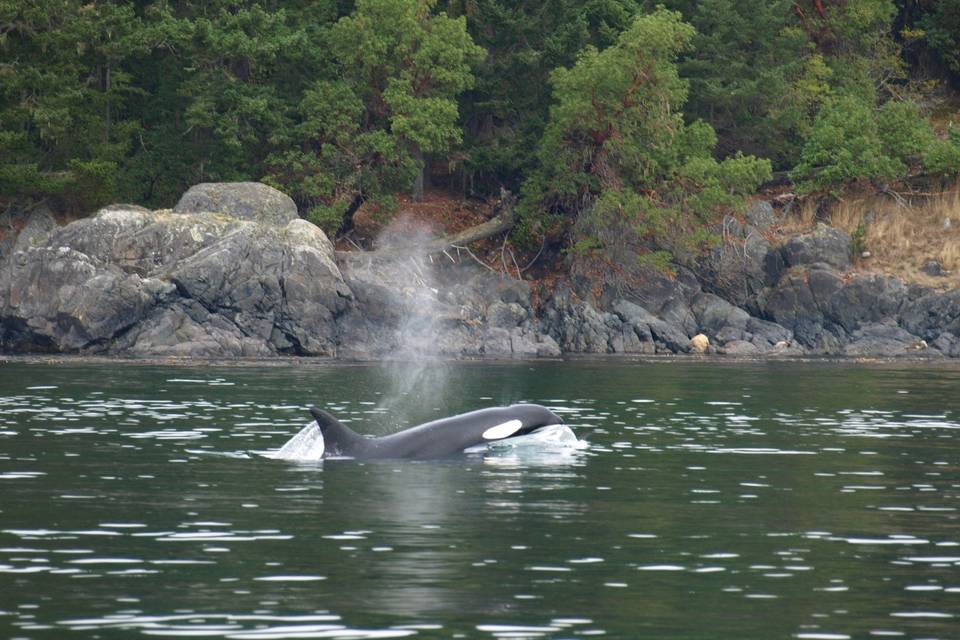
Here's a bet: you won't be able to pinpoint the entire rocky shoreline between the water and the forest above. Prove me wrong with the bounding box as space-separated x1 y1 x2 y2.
0 183 960 360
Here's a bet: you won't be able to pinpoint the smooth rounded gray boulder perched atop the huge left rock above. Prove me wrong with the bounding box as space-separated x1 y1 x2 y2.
173 182 299 225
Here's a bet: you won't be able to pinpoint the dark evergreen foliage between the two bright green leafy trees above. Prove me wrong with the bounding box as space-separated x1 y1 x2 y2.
441 0 643 193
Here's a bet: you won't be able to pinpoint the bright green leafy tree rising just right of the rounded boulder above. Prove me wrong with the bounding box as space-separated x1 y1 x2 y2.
267 0 483 222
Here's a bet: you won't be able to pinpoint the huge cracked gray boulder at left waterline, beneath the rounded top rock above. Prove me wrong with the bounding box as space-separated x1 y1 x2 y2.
0 188 352 356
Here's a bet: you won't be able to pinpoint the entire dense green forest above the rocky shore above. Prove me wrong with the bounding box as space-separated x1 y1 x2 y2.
0 0 960 261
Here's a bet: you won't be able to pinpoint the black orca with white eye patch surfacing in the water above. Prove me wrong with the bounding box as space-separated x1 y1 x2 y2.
310 404 563 459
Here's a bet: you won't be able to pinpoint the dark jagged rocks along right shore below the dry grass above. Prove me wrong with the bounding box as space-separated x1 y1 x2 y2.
544 203 960 358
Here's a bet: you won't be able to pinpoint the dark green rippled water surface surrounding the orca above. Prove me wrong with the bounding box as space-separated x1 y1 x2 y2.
0 362 960 640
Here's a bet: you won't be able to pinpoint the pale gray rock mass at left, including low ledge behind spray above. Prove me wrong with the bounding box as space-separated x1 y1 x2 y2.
0 183 560 358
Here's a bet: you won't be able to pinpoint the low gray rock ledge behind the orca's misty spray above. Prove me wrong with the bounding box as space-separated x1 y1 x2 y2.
338 251 561 359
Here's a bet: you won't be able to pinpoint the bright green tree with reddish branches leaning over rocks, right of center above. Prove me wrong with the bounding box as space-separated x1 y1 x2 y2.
521 9 770 259
